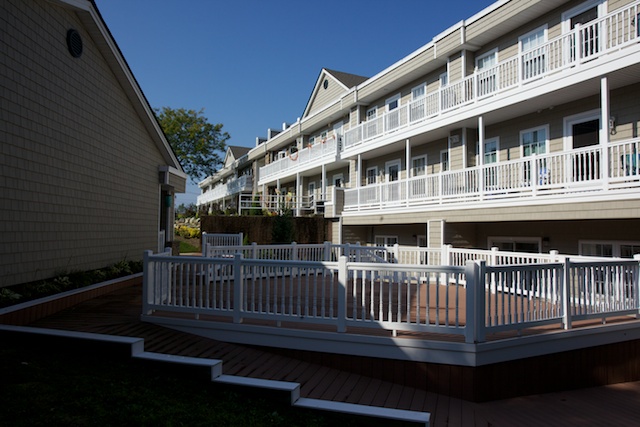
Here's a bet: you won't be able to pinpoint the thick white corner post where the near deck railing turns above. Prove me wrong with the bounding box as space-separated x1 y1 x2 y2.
464 261 486 344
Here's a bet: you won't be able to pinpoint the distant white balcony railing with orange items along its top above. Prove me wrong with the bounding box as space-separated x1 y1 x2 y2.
260 136 339 180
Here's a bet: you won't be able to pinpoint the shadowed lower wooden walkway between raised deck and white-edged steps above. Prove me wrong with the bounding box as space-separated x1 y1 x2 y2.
3 285 640 426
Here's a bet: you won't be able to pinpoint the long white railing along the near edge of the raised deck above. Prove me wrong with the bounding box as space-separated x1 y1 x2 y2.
143 251 640 343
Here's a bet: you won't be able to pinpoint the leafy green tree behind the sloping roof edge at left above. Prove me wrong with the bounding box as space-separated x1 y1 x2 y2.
155 107 230 182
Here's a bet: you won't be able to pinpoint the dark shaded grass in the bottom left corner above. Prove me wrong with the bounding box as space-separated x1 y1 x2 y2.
0 340 371 427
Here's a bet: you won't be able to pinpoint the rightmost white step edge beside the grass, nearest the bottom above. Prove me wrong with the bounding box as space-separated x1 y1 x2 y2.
294 397 431 427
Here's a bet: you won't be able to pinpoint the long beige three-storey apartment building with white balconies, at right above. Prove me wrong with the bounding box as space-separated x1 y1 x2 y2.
199 0 640 257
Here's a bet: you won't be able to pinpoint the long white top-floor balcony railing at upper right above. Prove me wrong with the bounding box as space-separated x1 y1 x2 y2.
344 2 640 149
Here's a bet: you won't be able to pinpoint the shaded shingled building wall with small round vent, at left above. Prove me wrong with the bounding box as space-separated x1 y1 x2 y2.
0 0 186 287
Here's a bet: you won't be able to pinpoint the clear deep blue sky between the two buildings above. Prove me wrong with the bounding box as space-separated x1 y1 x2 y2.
96 0 494 205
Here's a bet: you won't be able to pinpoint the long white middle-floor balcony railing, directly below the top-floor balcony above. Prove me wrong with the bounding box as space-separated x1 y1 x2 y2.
344 138 640 212
